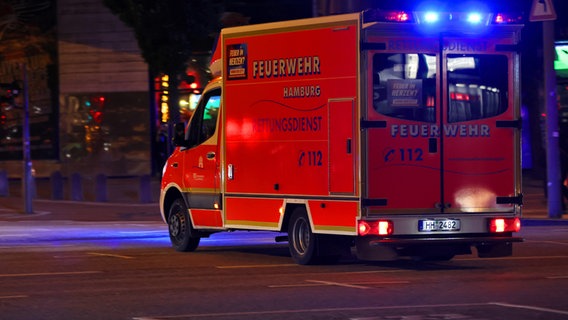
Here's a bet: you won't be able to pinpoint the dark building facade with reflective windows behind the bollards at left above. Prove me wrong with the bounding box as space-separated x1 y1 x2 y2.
0 0 150 177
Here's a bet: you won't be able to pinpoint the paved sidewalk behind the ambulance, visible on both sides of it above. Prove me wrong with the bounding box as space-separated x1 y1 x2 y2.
0 175 568 225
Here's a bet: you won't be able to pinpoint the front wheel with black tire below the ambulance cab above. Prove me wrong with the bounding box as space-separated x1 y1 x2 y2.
168 199 201 252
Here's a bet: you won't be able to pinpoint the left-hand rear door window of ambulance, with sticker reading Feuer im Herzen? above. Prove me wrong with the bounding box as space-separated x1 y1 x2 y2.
373 53 436 123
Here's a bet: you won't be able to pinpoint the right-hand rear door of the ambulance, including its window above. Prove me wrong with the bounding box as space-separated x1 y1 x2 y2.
440 36 521 213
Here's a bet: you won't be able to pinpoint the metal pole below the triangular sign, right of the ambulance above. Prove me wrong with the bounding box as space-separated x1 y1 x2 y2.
542 20 562 218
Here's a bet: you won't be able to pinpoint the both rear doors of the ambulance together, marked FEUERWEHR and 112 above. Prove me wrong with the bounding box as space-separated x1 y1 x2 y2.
361 35 517 213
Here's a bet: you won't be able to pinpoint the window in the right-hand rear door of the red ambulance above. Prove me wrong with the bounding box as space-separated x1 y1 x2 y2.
447 54 509 122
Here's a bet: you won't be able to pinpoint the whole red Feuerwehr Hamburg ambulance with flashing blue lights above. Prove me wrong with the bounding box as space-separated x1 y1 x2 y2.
160 10 522 264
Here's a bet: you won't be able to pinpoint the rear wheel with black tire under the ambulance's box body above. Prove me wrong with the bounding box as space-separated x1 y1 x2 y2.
288 208 318 265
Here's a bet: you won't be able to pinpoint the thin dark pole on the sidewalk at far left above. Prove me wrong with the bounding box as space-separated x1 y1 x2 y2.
20 64 33 213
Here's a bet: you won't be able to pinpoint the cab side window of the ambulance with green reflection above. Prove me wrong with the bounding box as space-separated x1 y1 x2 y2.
186 89 221 148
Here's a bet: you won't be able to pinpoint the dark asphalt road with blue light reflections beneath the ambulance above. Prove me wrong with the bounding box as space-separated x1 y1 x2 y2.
0 220 568 320
